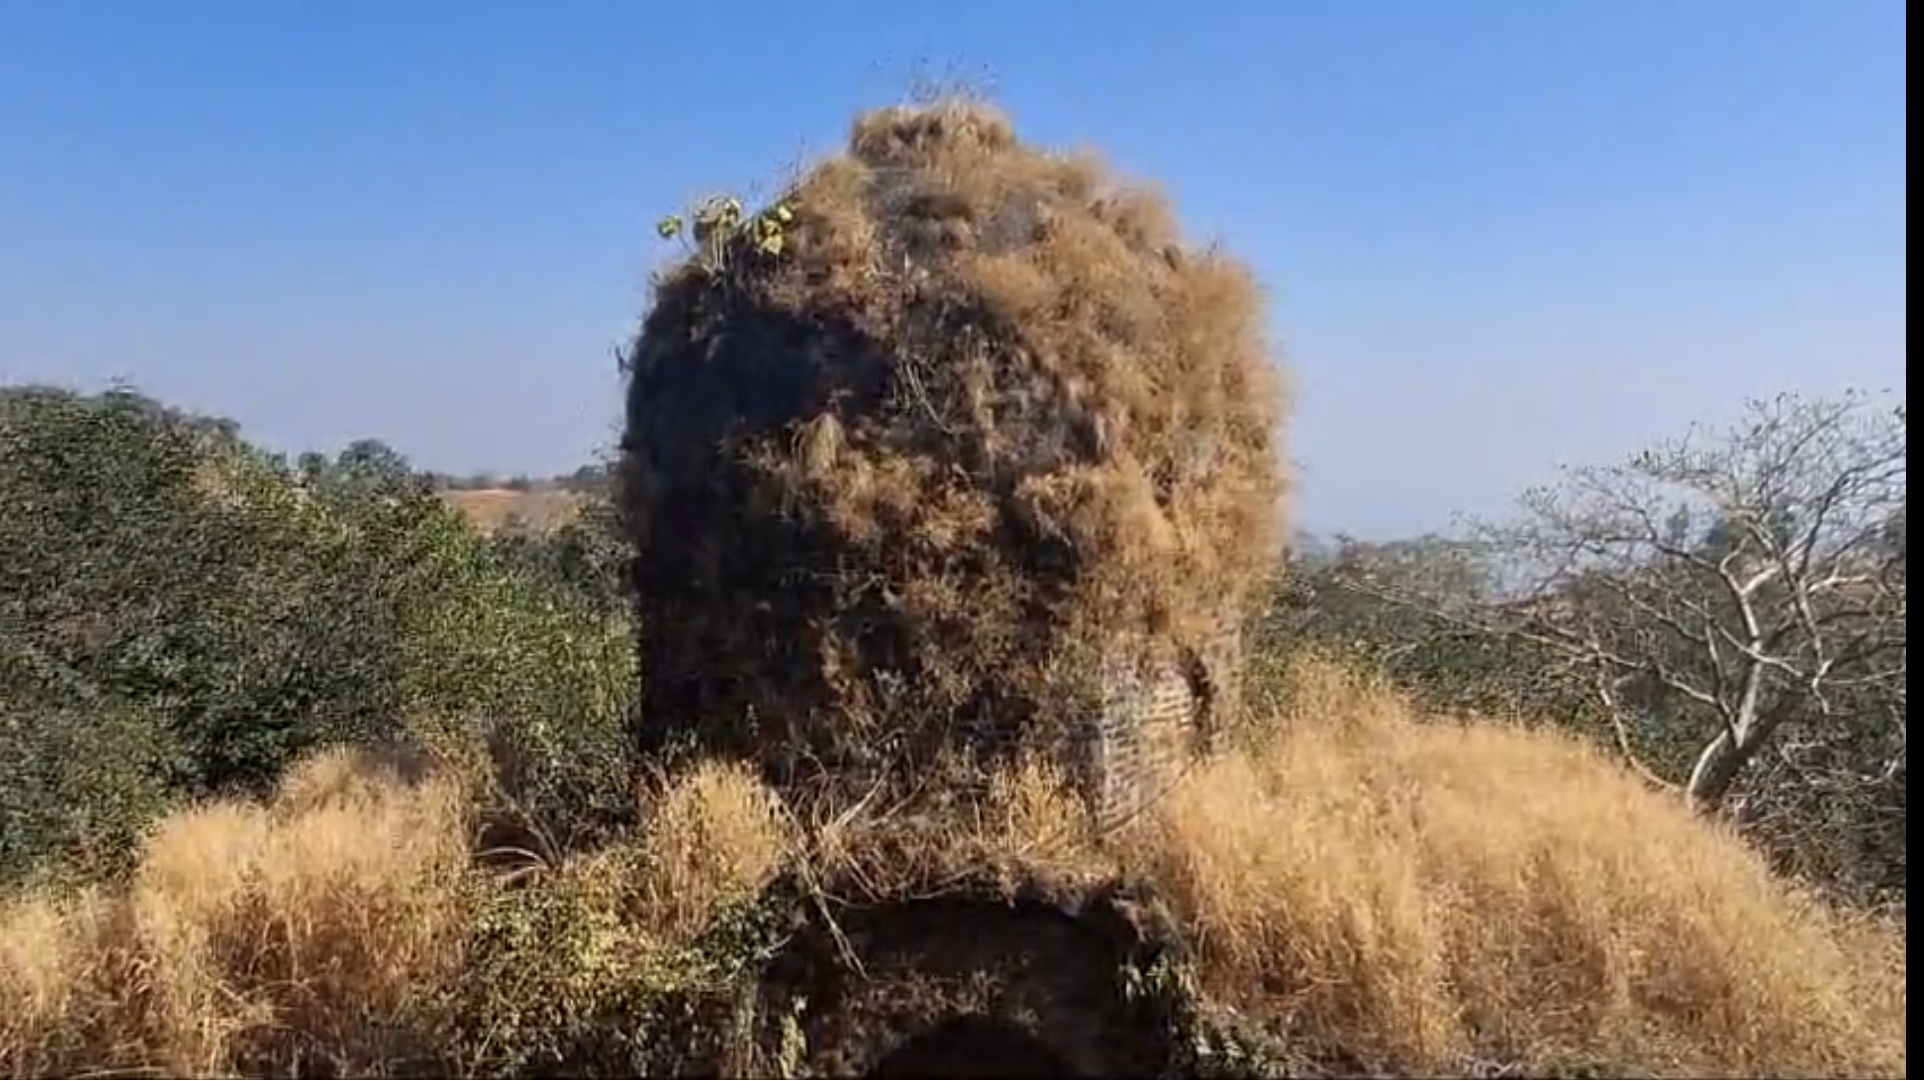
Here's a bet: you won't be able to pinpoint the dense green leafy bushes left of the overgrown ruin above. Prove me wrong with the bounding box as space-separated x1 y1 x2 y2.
0 389 633 874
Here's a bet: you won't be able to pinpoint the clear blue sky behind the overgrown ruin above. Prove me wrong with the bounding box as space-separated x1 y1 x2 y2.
0 0 1907 533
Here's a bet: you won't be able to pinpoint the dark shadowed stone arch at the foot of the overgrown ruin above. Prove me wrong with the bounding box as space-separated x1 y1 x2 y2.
756 877 1187 1078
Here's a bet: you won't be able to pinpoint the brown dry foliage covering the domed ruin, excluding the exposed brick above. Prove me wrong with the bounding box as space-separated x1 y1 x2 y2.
621 102 1287 800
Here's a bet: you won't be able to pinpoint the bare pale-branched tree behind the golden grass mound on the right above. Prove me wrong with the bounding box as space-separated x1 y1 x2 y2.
1356 395 1907 810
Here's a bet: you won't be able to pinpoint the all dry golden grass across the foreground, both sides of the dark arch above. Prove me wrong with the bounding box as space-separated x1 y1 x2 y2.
0 664 1907 1076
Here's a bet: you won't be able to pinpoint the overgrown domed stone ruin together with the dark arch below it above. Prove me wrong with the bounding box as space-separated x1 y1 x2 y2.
620 102 1289 1076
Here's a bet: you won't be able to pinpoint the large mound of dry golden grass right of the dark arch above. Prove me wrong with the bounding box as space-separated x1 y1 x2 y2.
1143 664 1905 1076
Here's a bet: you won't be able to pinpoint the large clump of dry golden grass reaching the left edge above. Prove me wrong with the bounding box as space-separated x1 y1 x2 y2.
0 753 468 1076
